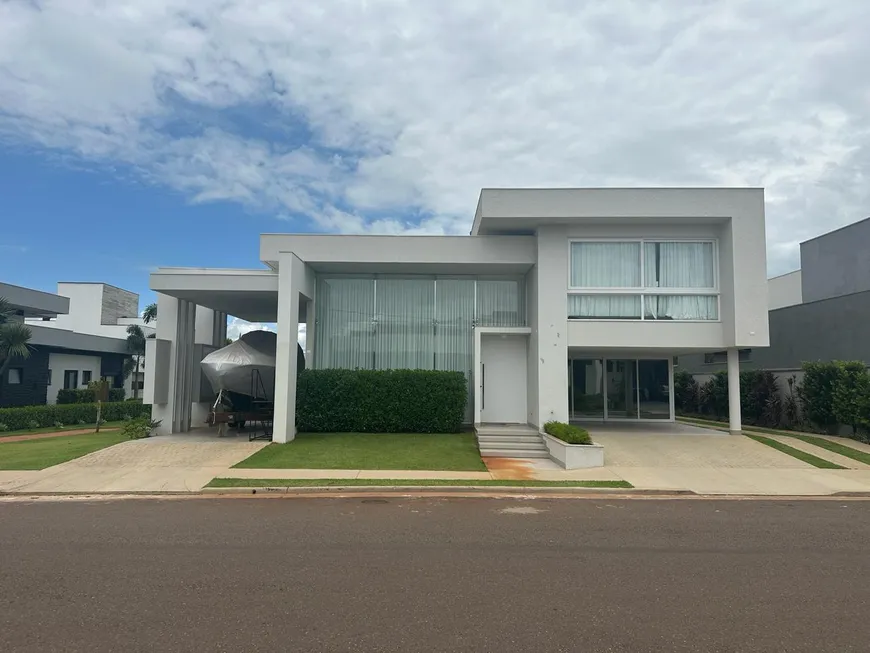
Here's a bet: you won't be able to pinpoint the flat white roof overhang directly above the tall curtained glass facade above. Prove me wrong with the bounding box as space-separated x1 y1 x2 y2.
260 234 535 275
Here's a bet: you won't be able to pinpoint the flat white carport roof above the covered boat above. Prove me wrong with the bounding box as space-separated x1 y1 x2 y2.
149 268 278 322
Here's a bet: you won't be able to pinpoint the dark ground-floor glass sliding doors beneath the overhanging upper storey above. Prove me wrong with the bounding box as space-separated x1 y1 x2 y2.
568 358 673 420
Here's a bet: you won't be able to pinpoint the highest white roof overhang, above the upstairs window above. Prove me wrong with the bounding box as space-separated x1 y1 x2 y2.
471 188 764 236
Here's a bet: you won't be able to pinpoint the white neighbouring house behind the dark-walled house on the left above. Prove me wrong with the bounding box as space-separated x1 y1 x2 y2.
26 281 157 403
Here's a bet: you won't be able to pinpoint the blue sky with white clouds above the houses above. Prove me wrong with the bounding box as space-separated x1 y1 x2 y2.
0 0 870 333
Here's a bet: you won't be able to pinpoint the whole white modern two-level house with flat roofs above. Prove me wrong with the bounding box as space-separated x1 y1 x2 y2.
145 188 768 442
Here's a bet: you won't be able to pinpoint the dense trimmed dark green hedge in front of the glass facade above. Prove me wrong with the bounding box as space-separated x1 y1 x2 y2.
296 370 467 433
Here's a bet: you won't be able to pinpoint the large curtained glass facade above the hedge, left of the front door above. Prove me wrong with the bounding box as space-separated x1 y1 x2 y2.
314 276 526 421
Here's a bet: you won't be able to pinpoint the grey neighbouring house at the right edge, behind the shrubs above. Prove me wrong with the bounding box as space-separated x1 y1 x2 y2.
679 218 870 378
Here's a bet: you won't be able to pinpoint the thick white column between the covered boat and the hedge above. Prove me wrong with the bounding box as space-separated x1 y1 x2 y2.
272 253 304 442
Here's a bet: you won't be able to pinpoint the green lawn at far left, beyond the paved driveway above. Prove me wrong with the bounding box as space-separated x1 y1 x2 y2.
0 431 126 470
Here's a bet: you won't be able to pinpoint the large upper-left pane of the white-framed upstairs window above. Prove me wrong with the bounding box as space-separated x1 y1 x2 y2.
571 243 641 288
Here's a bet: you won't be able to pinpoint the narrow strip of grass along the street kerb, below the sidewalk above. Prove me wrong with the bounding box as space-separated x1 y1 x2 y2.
206 478 634 488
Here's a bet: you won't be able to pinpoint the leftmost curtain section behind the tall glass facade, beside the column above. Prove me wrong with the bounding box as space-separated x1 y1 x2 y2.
314 278 375 369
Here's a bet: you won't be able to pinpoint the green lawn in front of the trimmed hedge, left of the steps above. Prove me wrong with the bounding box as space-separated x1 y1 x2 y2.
235 433 486 472
